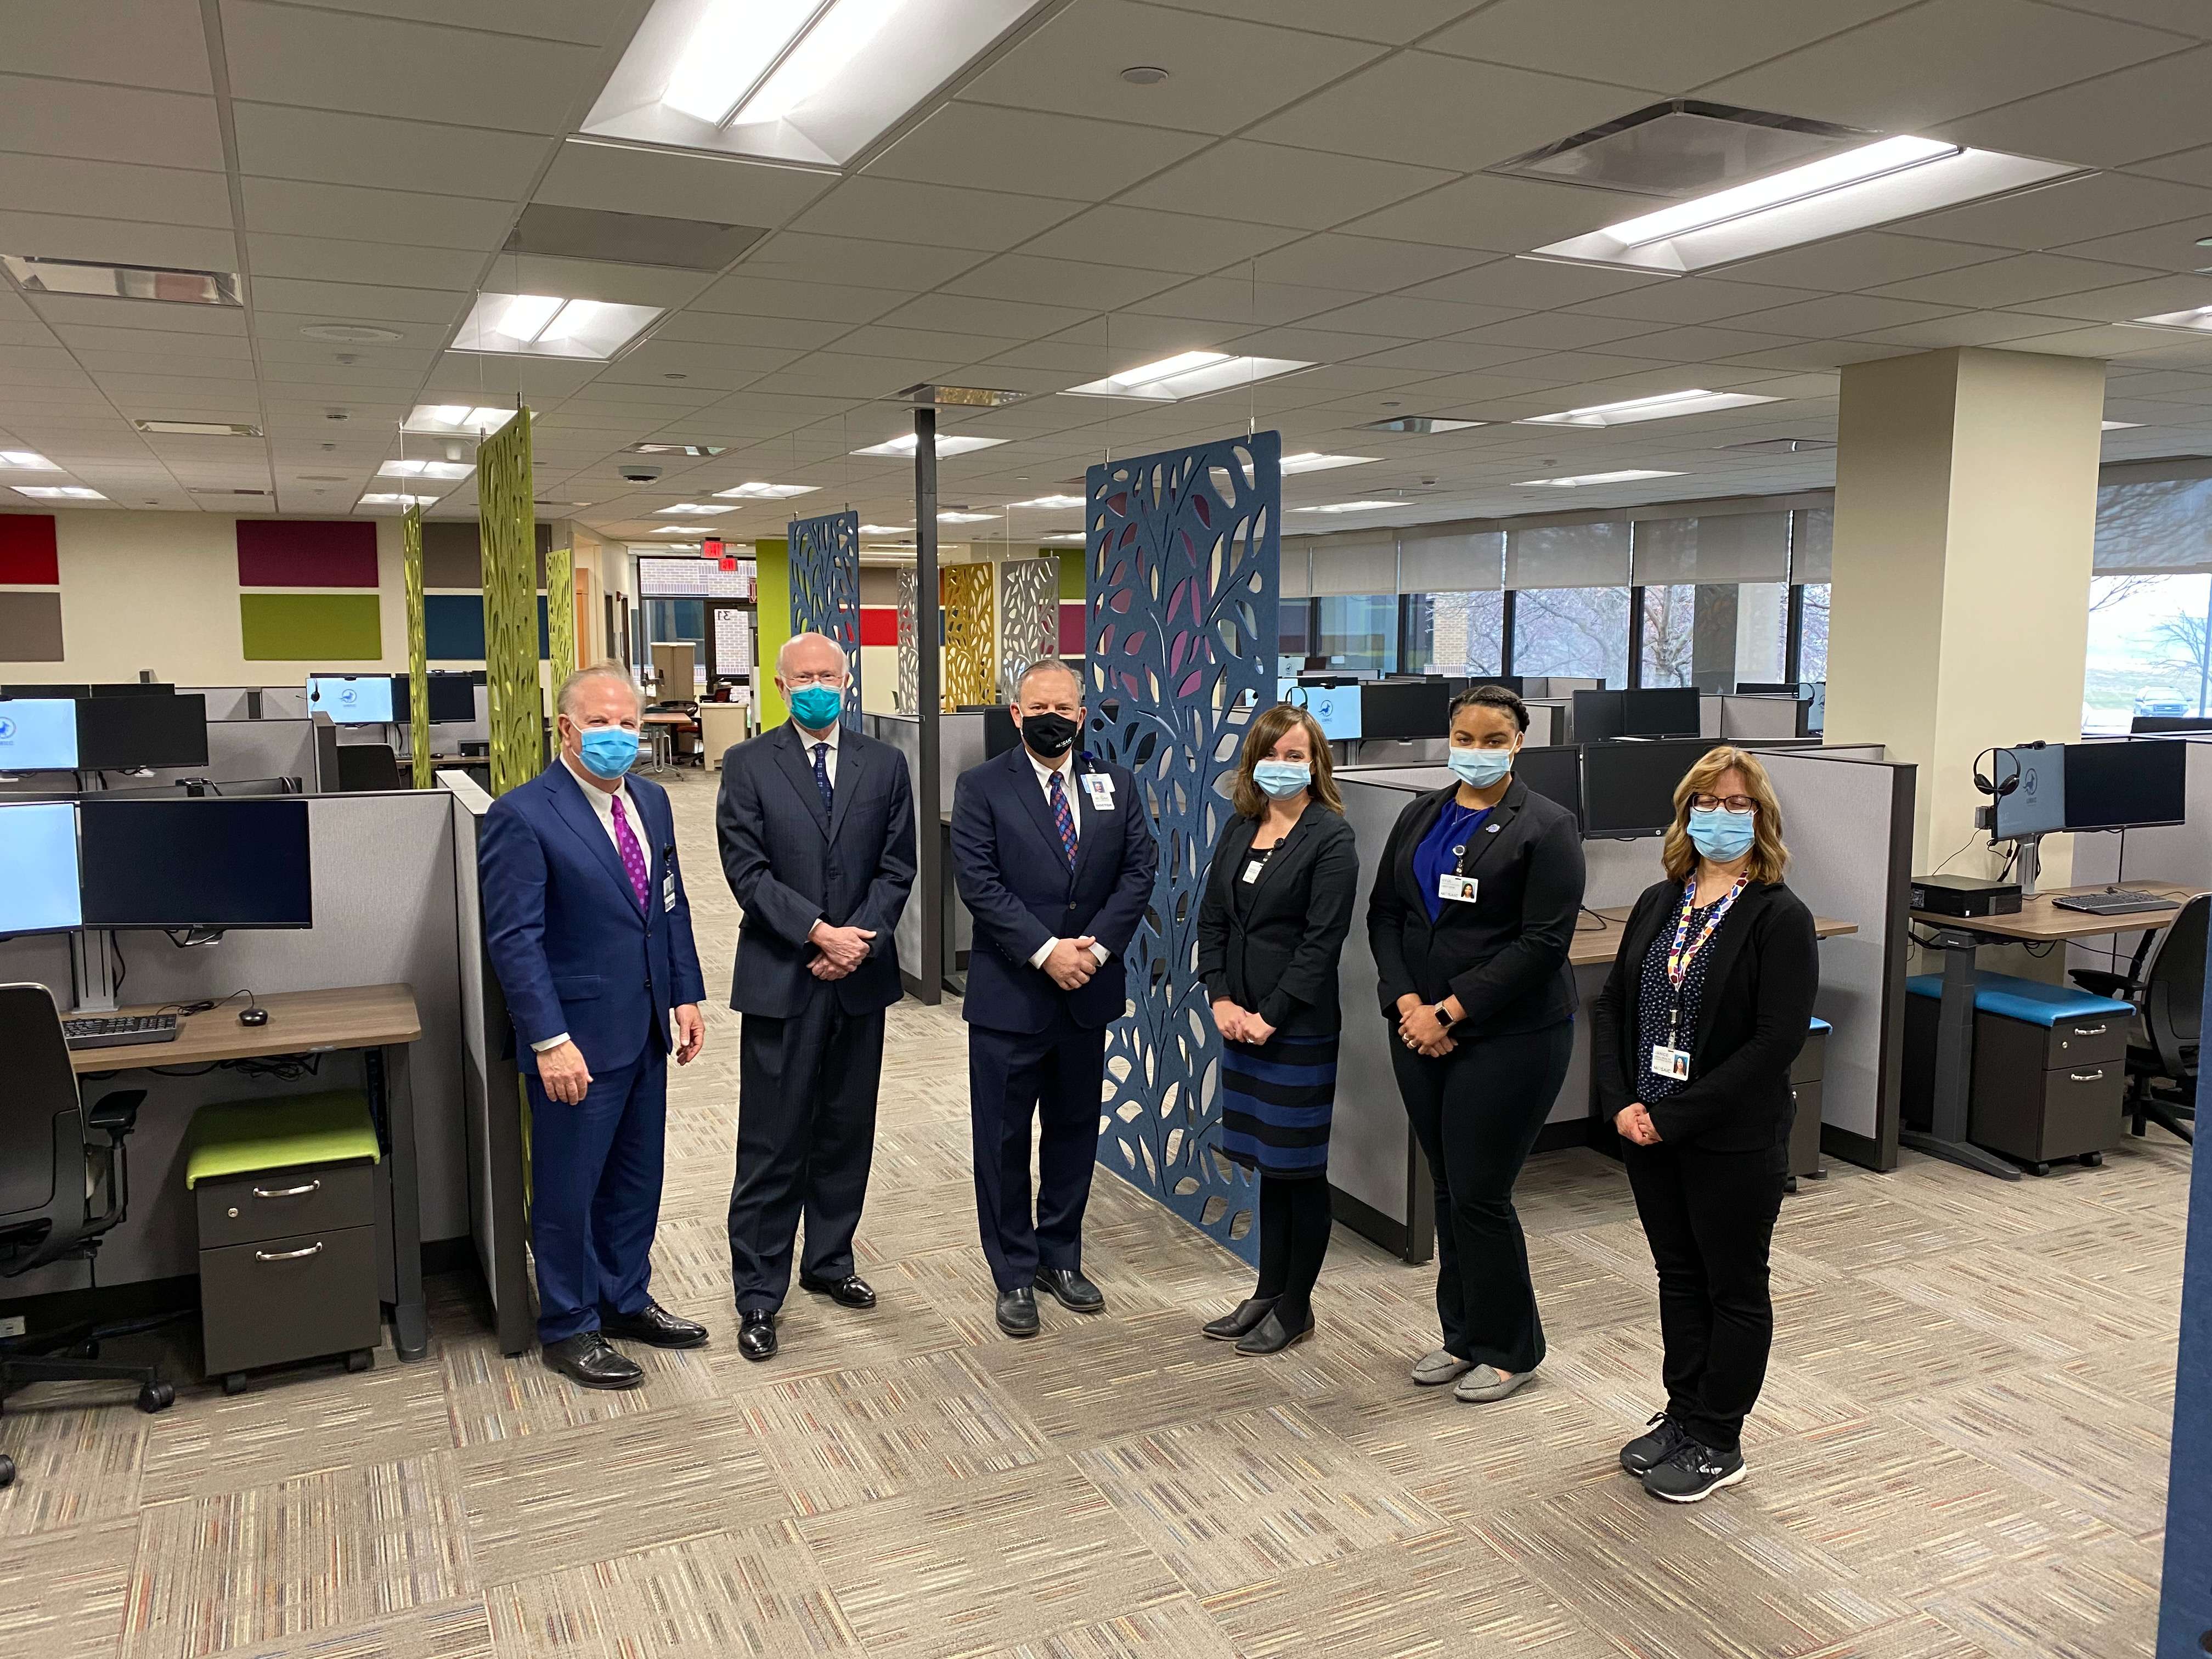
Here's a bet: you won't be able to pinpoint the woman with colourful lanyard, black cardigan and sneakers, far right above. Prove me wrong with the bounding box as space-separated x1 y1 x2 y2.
1590 748 1820 1504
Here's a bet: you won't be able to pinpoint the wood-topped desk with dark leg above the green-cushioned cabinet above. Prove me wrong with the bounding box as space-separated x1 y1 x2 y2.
69 984 429 1361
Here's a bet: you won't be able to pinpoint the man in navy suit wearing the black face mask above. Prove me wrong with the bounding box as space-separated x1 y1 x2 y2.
953 659 1159 1336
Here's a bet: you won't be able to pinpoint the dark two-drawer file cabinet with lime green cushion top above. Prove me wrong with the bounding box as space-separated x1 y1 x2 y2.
184 1091 383 1393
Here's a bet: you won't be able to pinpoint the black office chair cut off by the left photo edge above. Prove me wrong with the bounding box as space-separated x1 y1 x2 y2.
0 984 177 1487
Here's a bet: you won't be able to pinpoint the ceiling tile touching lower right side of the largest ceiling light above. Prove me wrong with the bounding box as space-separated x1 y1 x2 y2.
867 104 1205 201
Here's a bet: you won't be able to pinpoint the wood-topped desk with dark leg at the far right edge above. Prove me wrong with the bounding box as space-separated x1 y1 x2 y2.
1898 881 2203 1181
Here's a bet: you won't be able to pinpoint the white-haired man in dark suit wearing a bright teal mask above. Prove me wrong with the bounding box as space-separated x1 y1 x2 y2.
714 633 913 1361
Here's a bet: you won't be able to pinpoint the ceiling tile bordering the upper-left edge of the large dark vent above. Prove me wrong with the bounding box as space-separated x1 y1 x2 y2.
1250 51 1650 170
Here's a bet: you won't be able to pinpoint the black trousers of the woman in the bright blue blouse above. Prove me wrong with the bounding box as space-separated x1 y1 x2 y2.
1389 1022 1575 1372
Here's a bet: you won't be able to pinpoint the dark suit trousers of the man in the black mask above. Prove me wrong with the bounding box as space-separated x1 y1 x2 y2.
969 1009 1106 1290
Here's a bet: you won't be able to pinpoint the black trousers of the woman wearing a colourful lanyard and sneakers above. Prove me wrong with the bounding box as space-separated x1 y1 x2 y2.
1621 1142 1783 1451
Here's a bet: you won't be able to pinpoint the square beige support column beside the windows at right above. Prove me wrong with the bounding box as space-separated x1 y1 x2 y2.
1827 347 2103 885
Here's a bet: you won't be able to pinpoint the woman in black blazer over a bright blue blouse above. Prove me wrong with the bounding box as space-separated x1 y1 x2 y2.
1367 686 1582 1400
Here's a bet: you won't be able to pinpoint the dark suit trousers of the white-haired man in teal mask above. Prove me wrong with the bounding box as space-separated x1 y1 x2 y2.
730 980 883 1312
